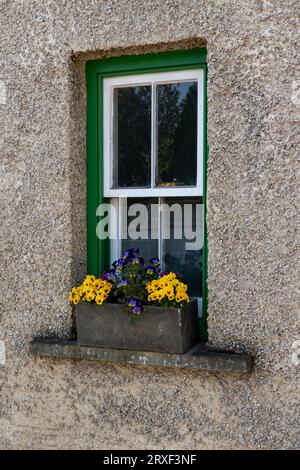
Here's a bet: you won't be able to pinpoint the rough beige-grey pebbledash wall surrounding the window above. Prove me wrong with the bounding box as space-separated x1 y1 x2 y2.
0 0 300 449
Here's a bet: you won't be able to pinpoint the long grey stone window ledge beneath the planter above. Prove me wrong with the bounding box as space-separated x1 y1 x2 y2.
29 340 252 374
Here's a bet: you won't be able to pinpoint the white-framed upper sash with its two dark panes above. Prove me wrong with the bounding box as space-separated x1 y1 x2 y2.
103 69 203 197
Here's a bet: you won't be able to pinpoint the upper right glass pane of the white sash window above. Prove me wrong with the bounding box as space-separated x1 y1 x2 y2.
156 82 197 187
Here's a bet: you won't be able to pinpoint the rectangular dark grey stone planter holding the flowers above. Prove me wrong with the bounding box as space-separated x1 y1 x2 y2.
75 300 199 353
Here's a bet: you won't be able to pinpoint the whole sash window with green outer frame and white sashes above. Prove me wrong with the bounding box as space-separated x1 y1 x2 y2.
87 50 206 340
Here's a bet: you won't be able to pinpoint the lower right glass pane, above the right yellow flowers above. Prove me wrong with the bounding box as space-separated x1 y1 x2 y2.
162 197 203 297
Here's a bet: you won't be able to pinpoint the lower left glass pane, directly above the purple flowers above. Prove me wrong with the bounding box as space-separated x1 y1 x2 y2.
121 198 158 263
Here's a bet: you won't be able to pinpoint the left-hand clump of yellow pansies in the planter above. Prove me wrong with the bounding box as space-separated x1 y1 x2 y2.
68 275 113 305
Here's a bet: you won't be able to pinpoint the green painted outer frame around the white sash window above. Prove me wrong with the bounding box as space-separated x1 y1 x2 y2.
86 48 208 341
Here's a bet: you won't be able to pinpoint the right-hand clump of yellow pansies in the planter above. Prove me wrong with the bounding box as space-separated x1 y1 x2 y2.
146 272 190 307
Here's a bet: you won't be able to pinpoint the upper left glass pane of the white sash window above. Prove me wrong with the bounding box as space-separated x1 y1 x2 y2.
113 86 151 188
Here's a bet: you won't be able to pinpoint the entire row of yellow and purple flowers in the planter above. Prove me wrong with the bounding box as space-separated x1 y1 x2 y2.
69 249 189 318
